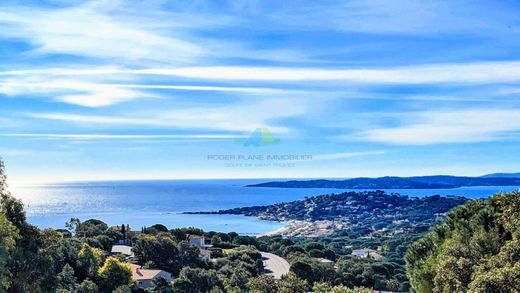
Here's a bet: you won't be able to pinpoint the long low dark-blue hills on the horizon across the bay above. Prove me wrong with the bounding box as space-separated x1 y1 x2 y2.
247 175 520 189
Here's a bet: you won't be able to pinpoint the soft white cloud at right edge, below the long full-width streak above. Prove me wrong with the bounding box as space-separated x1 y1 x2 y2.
356 109 520 145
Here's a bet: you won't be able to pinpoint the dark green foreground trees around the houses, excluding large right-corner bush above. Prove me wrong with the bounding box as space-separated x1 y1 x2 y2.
0 161 376 293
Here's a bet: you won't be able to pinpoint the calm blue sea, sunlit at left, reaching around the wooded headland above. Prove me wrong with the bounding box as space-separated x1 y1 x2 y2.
12 179 518 234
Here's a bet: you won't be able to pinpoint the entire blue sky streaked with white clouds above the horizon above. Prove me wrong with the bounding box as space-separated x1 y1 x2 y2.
0 0 520 184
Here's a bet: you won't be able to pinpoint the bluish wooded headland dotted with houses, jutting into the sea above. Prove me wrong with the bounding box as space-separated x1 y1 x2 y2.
199 190 467 236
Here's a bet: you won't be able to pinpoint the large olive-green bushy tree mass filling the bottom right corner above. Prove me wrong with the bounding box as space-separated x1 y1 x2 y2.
405 192 520 293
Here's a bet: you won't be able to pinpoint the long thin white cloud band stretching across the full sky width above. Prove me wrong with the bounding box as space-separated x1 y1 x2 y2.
4 61 520 84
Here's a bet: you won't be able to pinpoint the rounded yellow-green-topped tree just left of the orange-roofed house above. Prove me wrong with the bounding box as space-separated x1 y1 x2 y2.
98 256 132 291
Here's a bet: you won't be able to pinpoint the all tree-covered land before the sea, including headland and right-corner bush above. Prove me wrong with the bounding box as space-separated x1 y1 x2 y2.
0 157 520 293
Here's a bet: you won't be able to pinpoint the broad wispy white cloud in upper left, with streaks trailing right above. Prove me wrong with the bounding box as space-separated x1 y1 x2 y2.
0 1 311 67
